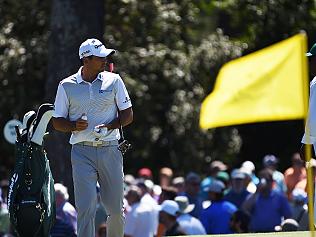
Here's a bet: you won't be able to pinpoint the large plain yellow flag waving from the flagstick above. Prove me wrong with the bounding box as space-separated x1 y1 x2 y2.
200 33 308 129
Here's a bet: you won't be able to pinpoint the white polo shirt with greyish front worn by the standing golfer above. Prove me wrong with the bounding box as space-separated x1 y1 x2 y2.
53 67 132 144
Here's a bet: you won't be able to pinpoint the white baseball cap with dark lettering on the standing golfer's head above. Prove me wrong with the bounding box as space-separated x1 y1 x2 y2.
79 39 115 59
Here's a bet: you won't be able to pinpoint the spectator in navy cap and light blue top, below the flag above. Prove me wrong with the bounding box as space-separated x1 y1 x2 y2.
263 155 286 193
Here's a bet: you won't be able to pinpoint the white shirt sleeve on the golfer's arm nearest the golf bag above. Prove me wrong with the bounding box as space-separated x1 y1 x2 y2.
53 83 69 118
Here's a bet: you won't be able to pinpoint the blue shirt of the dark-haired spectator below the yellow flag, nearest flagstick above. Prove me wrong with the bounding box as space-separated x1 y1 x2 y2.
250 190 292 232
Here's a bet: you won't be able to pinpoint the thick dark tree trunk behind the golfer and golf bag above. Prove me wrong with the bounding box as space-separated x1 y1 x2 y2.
45 0 104 202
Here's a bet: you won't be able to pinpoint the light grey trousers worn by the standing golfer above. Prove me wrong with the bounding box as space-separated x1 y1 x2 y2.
71 144 125 237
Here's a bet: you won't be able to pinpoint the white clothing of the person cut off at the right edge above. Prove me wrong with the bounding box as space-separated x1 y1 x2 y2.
302 77 316 152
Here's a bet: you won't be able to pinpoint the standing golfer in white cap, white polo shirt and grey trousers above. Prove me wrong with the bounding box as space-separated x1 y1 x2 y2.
52 39 133 237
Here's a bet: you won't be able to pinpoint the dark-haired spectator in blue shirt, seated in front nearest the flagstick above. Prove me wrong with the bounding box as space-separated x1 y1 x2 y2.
242 169 291 232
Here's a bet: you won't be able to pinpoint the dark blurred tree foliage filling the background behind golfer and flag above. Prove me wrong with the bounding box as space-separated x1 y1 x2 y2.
0 0 315 181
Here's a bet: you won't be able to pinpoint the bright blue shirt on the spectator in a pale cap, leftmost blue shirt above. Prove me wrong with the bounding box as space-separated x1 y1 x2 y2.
200 200 237 234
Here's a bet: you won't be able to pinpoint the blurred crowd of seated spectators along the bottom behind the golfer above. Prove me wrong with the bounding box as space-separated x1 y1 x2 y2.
0 153 316 237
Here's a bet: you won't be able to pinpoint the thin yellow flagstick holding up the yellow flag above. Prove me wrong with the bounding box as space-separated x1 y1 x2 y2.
301 33 315 237
